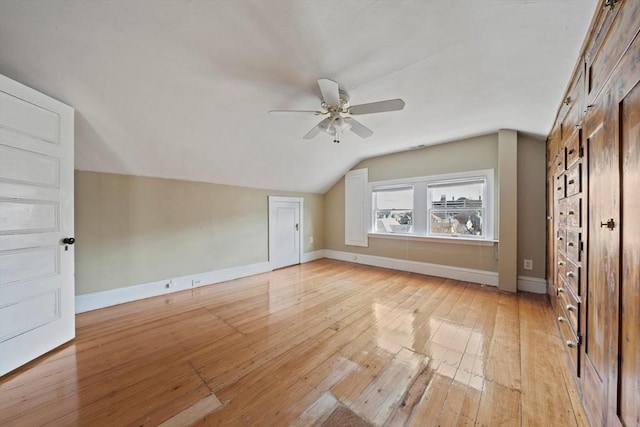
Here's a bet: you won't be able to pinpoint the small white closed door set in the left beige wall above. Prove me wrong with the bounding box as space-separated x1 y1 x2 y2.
269 197 303 269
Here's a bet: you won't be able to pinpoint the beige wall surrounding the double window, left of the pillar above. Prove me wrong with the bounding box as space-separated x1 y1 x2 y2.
324 134 500 271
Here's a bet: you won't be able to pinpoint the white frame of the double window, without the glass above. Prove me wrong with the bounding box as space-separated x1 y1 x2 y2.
367 169 496 242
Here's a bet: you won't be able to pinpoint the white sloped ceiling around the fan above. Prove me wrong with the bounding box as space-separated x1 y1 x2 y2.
0 0 598 193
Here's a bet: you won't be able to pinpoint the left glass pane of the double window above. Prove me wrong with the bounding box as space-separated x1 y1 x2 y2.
373 187 413 233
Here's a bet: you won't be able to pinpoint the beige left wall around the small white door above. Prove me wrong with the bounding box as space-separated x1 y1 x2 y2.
75 171 324 295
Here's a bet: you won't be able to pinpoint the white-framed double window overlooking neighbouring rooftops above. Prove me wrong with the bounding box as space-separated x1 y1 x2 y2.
369 169 494 240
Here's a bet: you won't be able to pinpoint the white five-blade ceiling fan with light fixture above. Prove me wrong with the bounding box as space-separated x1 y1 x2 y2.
269 79 404 143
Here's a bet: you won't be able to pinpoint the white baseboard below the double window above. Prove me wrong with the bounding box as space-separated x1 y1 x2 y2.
324 249 498 286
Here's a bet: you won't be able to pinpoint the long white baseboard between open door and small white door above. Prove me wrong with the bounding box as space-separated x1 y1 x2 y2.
76 262 271 313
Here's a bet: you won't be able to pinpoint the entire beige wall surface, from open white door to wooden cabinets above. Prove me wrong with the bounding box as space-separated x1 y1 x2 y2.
75 134 546 295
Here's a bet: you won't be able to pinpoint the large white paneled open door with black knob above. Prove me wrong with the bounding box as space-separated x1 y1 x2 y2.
0 75 75 375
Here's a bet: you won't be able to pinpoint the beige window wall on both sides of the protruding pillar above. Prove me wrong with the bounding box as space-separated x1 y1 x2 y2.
324 133 545 278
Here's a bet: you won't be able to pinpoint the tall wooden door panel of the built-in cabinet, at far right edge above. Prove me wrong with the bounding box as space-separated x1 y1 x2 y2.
618 78 640 426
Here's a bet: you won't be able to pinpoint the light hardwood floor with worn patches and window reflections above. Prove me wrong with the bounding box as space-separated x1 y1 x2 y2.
0 260 587 426
